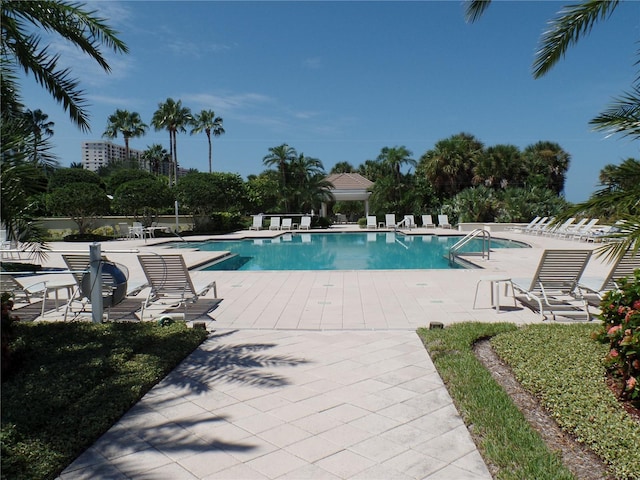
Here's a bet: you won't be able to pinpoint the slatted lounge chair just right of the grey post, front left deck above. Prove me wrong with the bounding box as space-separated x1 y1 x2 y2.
138 254 220 320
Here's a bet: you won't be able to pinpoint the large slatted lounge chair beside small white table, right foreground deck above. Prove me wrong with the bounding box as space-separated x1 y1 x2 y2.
512 250 592 320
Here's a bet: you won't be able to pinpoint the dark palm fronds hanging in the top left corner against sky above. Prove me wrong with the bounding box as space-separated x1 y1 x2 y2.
0 0 128 131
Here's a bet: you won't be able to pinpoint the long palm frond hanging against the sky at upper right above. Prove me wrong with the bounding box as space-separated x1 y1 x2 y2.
533 0 619 78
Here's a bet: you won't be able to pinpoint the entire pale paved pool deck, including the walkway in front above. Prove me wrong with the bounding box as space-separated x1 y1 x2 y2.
7 226 608 480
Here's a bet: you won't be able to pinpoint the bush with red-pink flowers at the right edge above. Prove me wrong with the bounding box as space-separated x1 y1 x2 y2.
596 270 640 406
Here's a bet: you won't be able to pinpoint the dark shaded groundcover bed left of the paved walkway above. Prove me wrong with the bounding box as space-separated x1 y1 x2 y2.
0 322 207 479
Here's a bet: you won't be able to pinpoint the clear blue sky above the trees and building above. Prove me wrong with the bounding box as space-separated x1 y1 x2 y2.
22 0 640 201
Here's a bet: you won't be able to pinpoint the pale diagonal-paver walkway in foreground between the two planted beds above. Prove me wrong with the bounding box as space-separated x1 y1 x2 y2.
61 330 491 480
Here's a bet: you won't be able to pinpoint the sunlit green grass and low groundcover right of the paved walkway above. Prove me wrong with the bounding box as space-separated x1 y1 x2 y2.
418 323 640 480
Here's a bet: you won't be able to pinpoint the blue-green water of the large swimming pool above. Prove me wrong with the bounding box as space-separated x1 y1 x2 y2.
174 232 524 270
